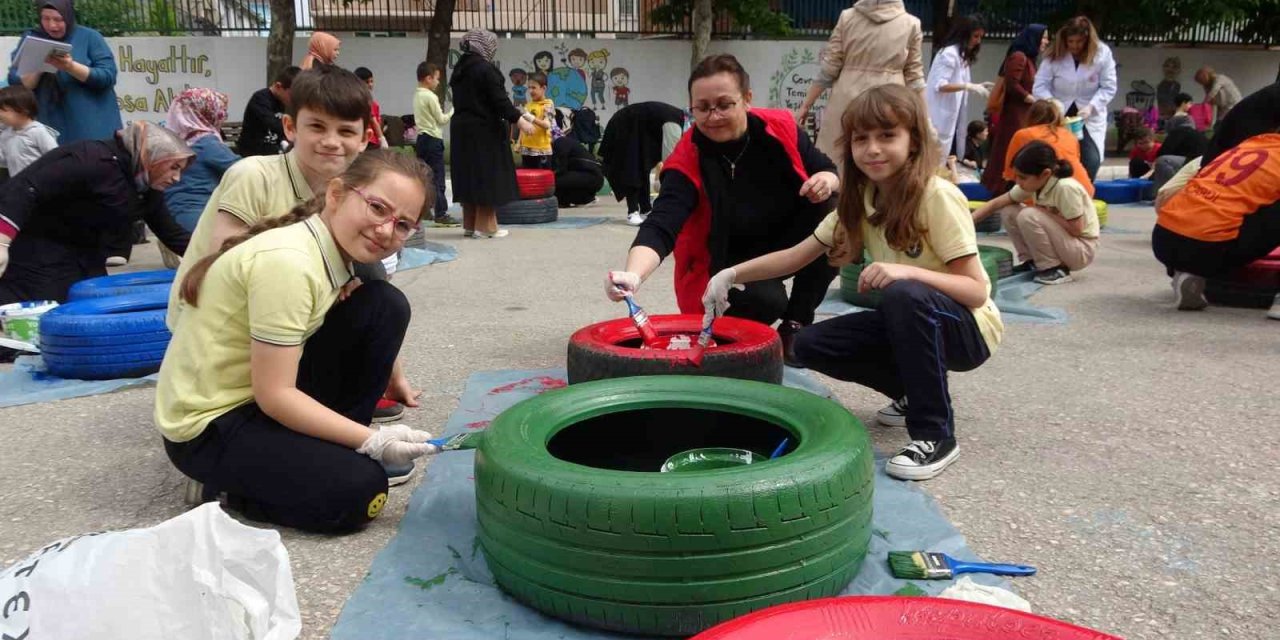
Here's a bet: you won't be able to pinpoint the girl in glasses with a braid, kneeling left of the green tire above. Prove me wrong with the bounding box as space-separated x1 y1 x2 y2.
155 150 439 531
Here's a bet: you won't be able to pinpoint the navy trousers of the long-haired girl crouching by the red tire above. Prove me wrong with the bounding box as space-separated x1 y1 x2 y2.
795 280 991 440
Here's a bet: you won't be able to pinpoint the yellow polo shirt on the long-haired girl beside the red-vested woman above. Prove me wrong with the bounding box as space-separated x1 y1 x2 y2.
813 178 1005 353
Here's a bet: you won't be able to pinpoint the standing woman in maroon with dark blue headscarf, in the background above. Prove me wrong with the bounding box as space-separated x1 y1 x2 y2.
982 24 1048 196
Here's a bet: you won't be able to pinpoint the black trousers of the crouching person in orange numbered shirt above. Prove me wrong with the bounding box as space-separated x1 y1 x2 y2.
1151 202 1280 278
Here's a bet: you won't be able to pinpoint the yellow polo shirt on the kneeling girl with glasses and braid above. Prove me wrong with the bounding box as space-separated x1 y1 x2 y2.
155 216 351 442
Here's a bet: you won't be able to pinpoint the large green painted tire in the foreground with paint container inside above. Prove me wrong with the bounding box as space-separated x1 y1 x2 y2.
475 376 874 636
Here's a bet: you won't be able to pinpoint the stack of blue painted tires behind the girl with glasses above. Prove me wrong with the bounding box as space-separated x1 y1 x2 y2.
40 270 174 380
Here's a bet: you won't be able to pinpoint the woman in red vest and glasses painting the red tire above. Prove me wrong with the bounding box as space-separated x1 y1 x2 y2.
605 54 840 366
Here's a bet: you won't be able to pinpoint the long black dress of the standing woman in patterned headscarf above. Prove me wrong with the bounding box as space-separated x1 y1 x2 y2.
449 54 520 206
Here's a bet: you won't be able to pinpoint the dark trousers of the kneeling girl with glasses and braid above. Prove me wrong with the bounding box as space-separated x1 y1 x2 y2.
164 282 410 532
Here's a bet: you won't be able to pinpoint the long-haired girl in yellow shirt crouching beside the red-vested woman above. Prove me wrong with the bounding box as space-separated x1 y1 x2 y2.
703 84 1004 480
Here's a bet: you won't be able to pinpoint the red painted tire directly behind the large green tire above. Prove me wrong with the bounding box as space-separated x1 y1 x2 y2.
568 315 782 384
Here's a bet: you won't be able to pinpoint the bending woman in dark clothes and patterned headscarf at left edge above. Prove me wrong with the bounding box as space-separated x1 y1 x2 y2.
0 122 192 305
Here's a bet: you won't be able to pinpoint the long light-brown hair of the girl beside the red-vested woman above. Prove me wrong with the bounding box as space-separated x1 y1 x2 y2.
837 84 938 260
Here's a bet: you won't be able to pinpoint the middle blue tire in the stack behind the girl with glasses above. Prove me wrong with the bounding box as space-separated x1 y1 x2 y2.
40 292 169 343
